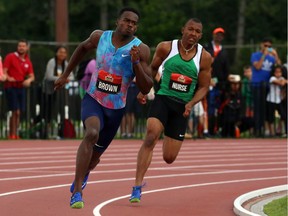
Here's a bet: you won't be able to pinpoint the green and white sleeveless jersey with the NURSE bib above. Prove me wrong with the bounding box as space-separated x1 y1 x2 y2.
157 40 203 102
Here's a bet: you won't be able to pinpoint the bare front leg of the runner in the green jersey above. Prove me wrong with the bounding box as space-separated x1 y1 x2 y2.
135 118 163 186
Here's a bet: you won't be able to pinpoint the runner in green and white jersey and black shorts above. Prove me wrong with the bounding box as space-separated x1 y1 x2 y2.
130 18 212 203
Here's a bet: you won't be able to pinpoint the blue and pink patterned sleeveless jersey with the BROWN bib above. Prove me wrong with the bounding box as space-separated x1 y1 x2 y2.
87 31 142 109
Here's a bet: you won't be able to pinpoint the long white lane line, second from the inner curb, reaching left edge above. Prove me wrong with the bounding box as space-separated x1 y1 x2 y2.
0 169 286 197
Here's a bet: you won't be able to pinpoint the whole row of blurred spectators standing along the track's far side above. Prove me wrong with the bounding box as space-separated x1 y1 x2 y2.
0 30 287 139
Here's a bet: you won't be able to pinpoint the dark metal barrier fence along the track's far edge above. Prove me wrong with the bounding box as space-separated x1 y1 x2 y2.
0 81 287 139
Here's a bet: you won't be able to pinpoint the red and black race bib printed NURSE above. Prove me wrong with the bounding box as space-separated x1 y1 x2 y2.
169 73 192 93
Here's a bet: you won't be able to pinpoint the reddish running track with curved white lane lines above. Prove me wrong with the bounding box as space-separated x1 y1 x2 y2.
0 139 287 216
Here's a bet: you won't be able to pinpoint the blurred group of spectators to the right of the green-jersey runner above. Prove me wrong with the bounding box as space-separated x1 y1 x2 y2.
186 27 287 138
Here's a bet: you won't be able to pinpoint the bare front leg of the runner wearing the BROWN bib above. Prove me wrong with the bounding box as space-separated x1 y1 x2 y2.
73 116 101 194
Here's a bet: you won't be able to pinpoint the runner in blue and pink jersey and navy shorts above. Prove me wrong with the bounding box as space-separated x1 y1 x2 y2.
55 8 153 208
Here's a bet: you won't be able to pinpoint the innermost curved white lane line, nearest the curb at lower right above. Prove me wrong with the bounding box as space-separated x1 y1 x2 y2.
93 176 286 216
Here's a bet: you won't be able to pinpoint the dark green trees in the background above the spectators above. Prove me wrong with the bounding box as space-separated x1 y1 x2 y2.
0 0 287 81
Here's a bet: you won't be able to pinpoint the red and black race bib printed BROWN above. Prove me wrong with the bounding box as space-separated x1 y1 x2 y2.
96 70 122 94
